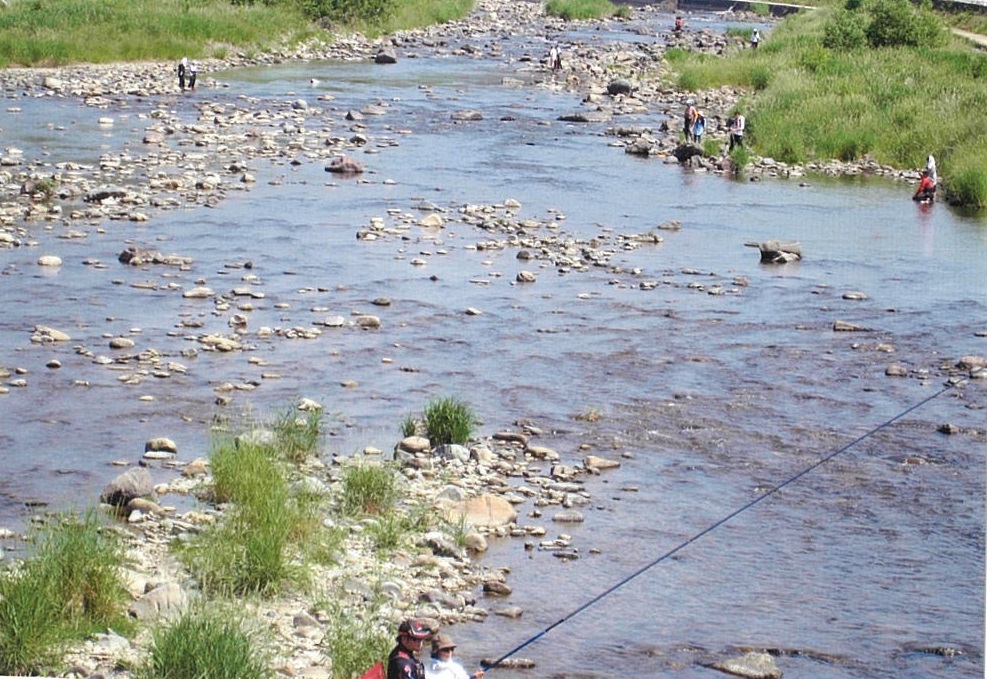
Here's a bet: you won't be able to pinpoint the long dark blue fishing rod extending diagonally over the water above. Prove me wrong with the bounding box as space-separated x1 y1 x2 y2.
481 380 964 670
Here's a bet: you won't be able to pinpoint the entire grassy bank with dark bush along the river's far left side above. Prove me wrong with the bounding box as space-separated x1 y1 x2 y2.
0 0 473 68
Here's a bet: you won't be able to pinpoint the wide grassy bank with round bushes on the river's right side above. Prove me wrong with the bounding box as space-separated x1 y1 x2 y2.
668 0 987 208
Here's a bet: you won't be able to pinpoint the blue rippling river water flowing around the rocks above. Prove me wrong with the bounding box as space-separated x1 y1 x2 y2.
0 11 987 679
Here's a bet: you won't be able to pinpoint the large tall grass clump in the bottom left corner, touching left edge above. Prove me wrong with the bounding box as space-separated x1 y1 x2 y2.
0 512 131 675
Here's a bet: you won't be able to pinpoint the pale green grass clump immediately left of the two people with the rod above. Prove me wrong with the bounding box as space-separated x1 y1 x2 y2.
323 603 394 679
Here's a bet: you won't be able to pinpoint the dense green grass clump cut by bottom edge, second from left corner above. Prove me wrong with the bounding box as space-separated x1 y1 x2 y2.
137 604 275 679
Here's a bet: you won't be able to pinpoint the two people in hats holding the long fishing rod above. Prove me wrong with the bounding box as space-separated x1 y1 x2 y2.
384 618 484 679
